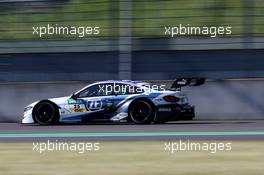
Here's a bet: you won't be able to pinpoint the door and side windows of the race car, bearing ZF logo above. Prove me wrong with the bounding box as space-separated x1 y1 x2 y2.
68 83 144 115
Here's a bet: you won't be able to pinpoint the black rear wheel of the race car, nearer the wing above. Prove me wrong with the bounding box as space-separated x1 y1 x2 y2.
128 100 156 124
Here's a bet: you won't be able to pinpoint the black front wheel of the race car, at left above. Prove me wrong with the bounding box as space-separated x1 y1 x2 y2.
33 100 59 125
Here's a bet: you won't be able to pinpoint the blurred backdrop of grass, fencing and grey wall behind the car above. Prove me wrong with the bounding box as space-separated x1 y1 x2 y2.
0 0 264 121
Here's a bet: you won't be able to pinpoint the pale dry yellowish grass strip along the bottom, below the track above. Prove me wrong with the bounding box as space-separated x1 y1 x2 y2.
0 141 264 175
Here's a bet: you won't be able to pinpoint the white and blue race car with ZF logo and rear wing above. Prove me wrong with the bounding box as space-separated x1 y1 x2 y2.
22 78 204 125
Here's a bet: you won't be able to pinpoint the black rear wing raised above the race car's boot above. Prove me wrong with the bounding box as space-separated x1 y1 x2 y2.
171 78 206 90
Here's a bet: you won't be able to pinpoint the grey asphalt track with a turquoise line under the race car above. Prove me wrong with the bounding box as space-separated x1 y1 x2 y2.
0 120 264 142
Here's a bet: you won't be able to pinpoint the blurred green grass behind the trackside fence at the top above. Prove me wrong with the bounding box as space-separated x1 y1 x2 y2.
0 0 264 40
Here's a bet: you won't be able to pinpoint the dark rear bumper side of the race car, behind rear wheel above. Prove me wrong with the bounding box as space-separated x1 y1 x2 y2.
154 104 195 122
